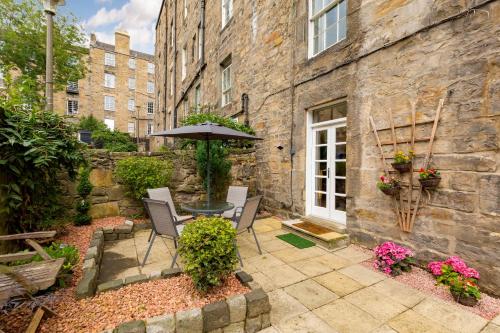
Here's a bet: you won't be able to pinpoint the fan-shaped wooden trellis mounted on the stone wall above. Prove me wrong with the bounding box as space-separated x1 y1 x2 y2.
369 93 446 232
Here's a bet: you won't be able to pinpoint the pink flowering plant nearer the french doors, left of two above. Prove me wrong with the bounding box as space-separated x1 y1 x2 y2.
374 242 414 276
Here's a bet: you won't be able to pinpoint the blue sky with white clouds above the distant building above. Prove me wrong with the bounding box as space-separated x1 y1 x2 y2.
60 0 162 53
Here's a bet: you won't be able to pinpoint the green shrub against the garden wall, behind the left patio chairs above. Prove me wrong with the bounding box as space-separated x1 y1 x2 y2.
115 157 172 200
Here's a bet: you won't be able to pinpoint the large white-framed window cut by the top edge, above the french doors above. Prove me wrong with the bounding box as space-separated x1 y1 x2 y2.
309 0 347 58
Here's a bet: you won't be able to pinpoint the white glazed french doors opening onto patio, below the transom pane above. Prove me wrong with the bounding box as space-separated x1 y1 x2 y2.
308 120 347 224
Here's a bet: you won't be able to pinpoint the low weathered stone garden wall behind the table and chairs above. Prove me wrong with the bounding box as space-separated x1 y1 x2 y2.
65 149 256 218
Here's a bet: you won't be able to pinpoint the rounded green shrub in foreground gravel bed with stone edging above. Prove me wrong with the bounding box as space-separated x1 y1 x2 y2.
179 217 238 292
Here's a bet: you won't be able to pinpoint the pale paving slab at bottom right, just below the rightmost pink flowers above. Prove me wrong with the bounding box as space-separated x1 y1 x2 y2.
413 297 487 333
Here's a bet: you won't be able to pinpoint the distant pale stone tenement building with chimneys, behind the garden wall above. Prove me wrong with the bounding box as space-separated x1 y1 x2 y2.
54 31 156 139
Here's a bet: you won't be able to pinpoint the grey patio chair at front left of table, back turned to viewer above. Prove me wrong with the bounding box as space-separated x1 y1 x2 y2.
141 198 184 268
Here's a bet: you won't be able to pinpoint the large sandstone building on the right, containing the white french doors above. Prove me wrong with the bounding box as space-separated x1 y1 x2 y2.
155 0 500 294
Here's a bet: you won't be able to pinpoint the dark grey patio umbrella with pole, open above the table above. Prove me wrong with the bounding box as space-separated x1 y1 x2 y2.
152 122 262 202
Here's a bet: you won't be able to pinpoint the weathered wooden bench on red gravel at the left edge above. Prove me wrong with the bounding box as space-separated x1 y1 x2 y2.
0 231 64 332
